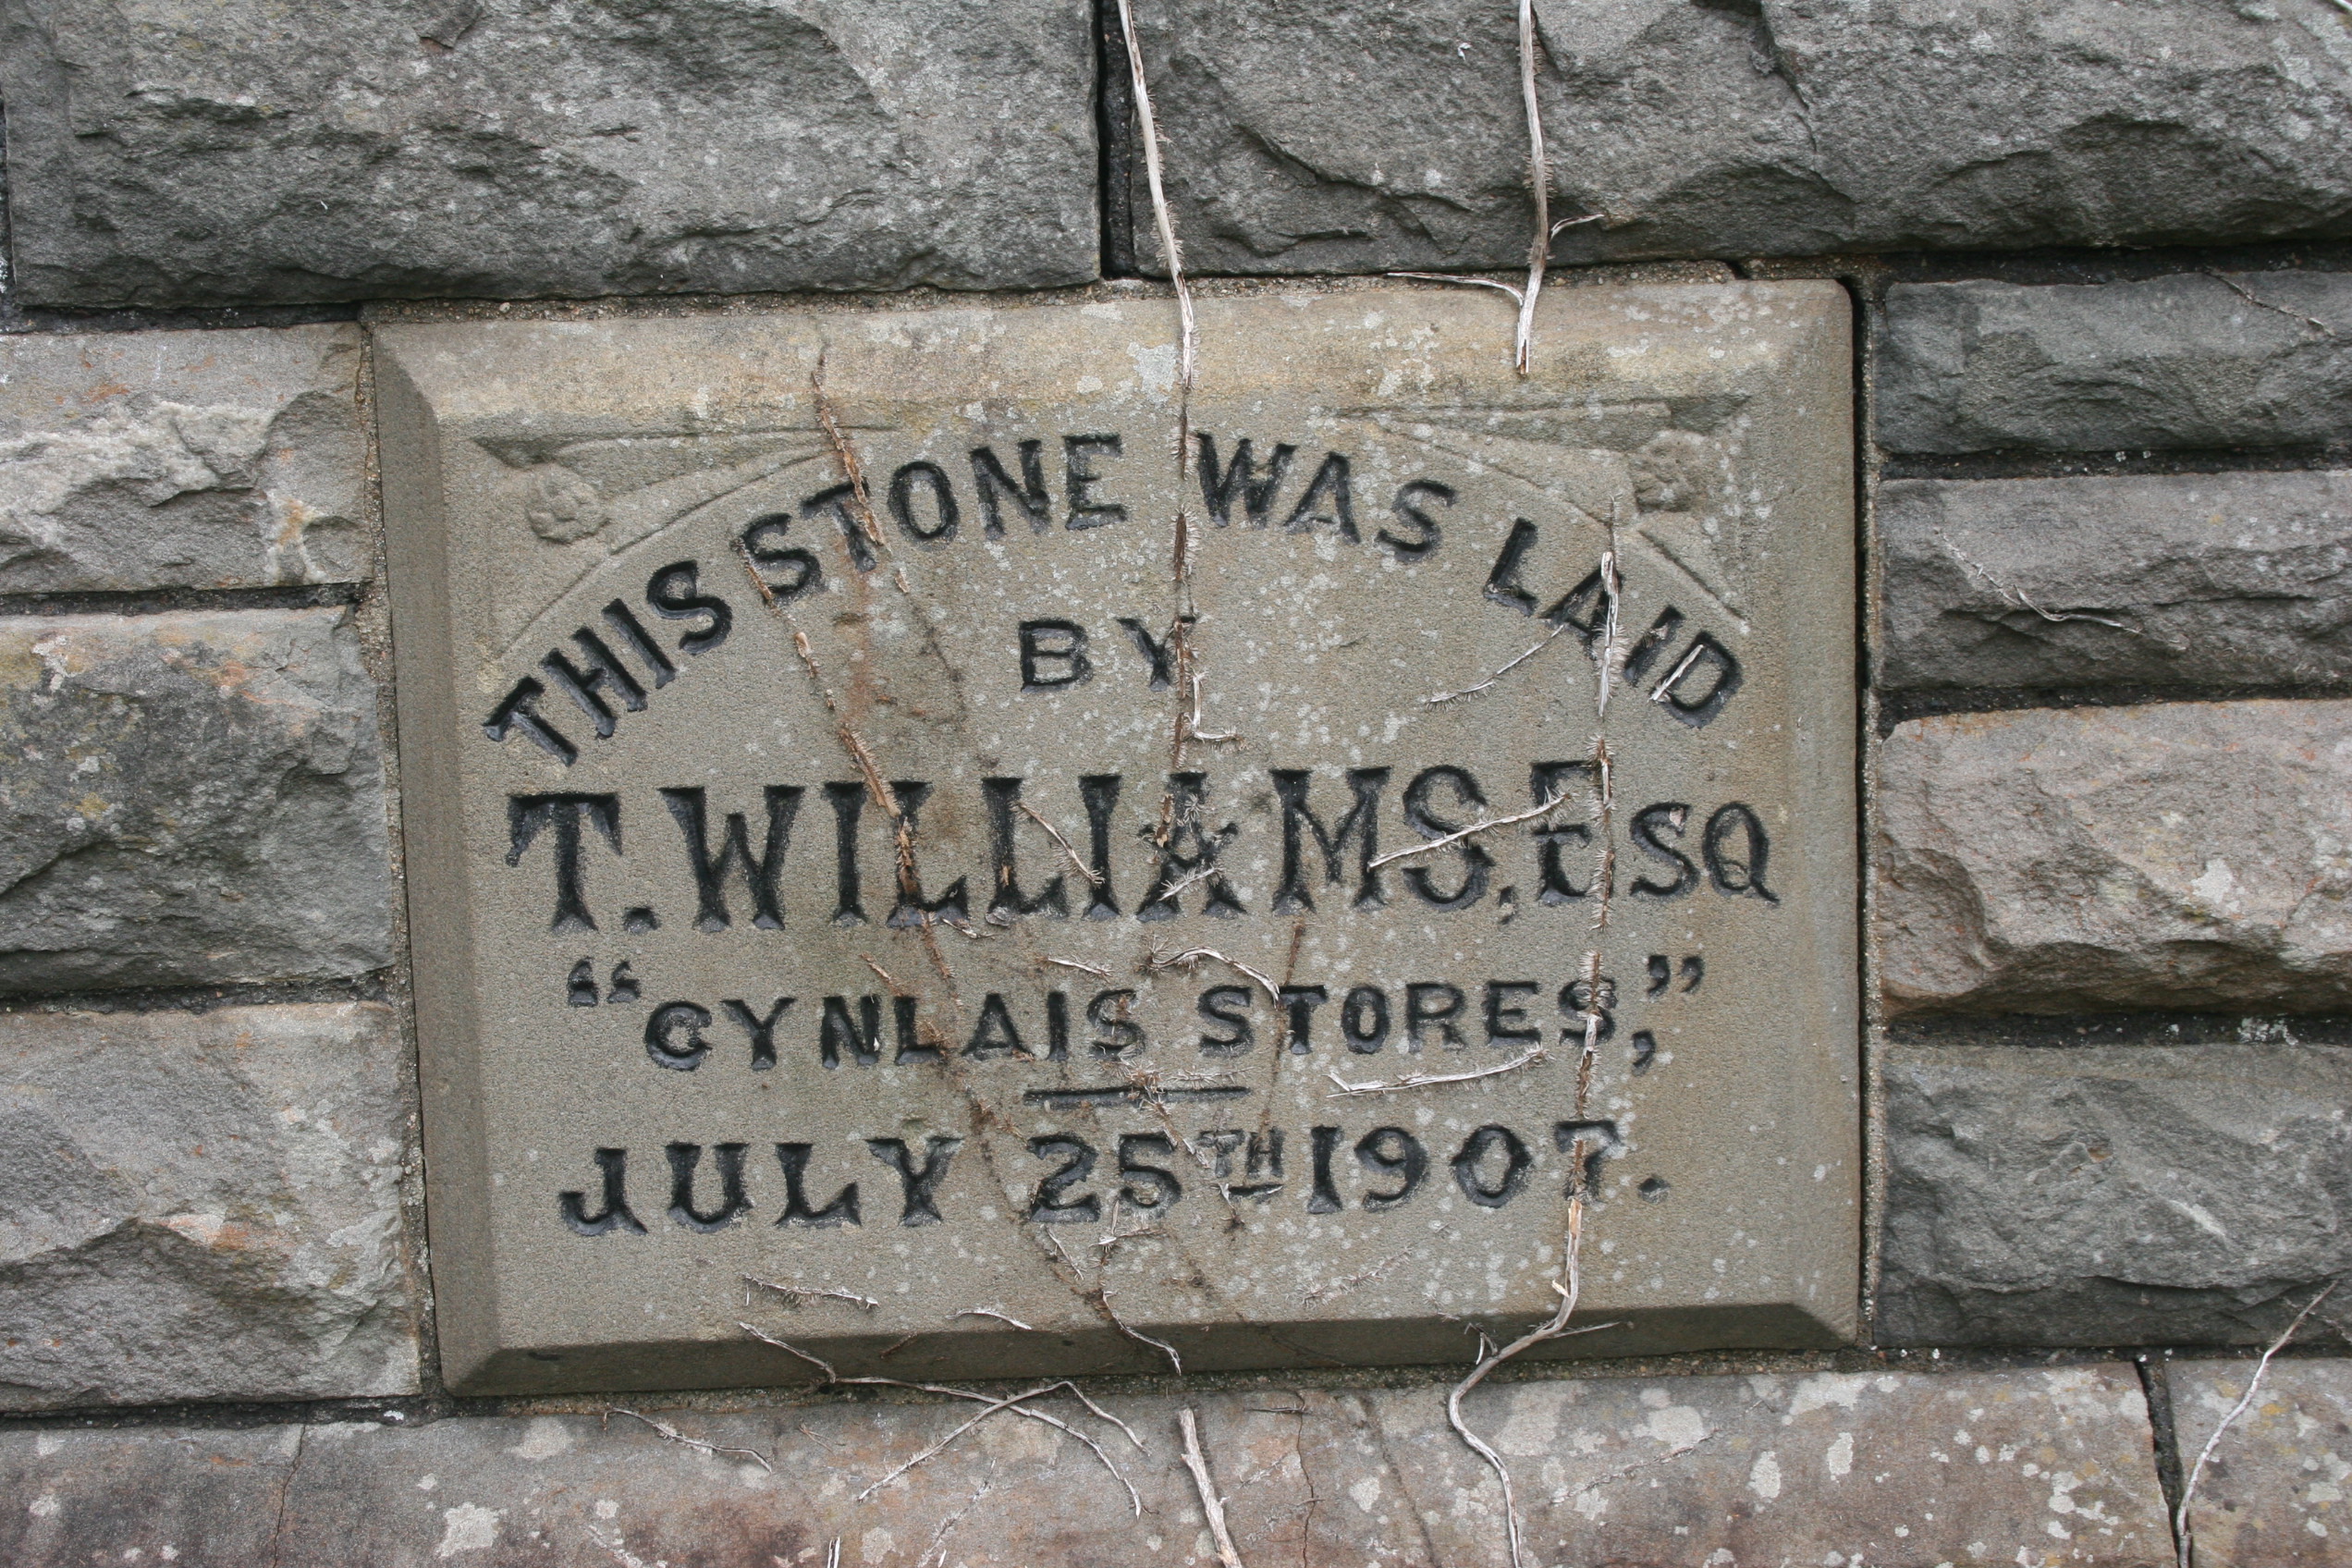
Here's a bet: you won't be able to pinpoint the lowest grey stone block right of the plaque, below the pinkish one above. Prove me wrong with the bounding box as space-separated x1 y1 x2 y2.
1877 1023 2352 1344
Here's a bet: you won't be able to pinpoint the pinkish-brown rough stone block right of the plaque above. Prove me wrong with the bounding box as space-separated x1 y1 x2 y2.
1877 701 2352 1013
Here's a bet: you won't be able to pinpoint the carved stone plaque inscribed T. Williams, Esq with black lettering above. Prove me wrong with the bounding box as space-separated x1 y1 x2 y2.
379 282 1860 1391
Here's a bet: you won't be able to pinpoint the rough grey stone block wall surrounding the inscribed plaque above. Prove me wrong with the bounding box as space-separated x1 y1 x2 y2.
0 0 2352 1568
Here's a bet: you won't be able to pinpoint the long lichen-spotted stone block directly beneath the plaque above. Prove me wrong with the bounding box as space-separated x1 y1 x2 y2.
0 1364 2169 1568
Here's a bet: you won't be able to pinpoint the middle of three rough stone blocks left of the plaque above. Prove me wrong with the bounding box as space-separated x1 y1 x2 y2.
0 609 390 992
